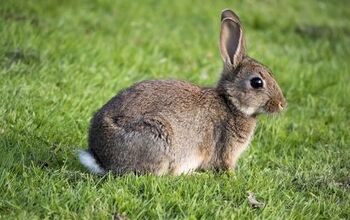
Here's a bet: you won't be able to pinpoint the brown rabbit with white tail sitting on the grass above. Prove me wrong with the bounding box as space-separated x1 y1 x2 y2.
79 9 287 175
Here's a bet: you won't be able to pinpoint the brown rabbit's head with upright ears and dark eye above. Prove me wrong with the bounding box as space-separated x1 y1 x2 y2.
218 10 287 115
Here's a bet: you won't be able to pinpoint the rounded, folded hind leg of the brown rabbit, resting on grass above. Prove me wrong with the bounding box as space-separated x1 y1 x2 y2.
104 118 174 175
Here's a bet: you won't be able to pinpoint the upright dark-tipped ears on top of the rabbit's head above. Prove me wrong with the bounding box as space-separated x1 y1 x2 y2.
220 10 245 69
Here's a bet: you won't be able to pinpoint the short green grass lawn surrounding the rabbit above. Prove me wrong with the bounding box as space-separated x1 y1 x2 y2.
0 0 350 219
